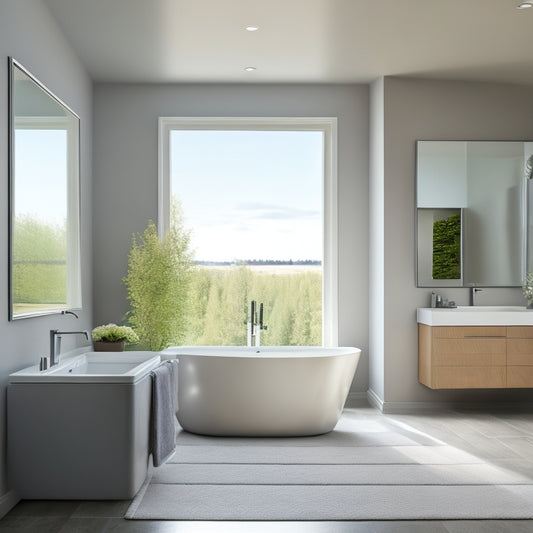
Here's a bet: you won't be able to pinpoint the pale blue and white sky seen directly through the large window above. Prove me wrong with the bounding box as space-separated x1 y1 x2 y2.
170 130 324 261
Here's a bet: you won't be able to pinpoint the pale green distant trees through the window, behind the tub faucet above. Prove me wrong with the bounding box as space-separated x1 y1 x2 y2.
183 265 322 346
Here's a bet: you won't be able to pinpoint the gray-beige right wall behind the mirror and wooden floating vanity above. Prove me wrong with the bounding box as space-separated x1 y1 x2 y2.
370 77 533 410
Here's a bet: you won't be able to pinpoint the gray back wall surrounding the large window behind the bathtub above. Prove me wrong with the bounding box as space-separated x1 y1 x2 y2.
93 84 368 391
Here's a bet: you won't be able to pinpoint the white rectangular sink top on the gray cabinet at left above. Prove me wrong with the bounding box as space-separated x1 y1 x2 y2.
9 351 161 383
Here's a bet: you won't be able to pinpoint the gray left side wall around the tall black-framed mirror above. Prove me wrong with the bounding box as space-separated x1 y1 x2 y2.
0 0 92 502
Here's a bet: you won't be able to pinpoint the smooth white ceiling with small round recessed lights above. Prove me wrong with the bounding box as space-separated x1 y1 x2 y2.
45 0 533 84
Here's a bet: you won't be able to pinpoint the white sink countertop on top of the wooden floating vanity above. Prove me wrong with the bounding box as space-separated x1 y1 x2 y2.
416 305 533 326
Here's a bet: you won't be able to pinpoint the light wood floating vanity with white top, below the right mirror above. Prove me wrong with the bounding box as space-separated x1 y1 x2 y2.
418 308 533 389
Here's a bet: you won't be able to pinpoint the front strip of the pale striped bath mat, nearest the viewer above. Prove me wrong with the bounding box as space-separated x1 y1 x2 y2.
126 484 533 520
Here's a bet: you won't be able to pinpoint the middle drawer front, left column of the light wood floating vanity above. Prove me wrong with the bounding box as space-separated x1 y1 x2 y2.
433 338 507 367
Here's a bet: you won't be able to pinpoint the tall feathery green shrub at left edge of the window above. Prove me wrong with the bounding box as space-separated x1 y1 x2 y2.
124 206 193 351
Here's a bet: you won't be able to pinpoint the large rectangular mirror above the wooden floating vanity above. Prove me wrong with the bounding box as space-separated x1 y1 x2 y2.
416 141 533 287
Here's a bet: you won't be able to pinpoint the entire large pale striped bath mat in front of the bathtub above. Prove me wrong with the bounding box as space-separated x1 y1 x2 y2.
126 411 533 520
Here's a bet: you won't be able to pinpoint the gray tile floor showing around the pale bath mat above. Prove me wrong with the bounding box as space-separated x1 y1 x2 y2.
0 407 533 533
